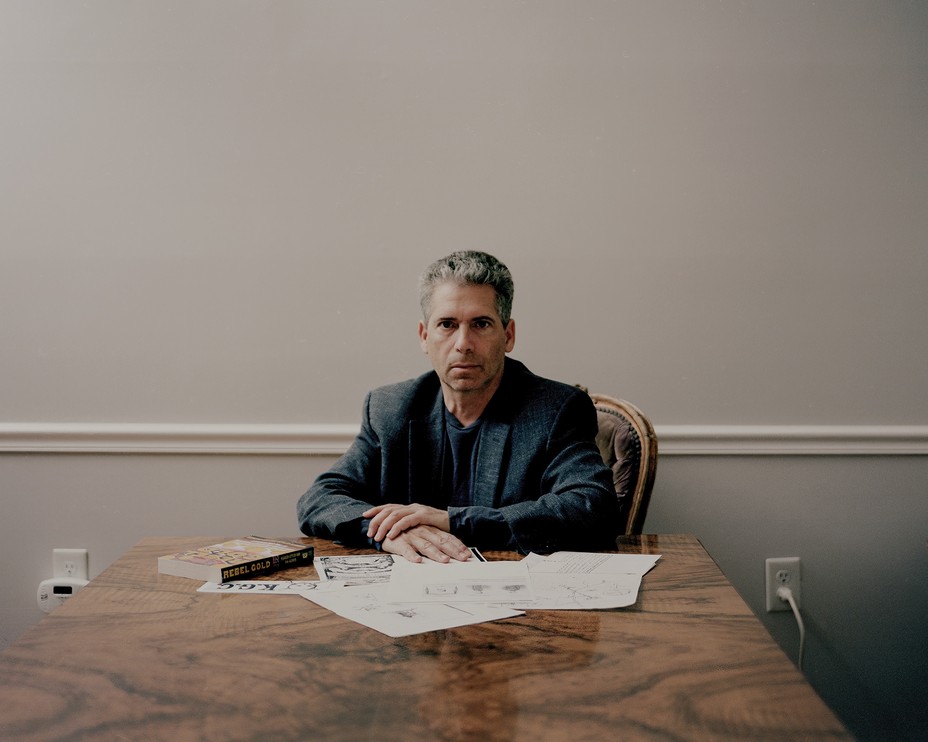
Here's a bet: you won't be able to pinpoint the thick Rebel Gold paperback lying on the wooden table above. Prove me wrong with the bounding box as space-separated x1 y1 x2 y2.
158 536 314 583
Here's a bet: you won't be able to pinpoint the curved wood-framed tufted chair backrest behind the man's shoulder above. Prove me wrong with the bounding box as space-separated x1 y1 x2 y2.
590 393 657 536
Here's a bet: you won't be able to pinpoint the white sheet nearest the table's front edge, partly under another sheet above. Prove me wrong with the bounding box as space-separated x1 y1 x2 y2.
302 584 522 637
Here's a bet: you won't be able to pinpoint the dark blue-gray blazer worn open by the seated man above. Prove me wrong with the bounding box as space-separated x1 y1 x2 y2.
297 358 619 553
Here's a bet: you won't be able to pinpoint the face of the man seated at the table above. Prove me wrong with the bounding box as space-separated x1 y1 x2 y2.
419 283 516 393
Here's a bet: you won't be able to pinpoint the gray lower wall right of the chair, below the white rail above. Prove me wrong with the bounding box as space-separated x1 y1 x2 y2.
646 456 928 740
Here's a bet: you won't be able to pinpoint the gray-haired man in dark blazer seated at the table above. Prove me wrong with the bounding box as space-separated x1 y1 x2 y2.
297 251 619 562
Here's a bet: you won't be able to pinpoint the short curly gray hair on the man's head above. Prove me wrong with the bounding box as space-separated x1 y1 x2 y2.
419 250 515 326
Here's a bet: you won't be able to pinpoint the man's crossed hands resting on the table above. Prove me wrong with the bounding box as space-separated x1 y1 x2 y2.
363 502 471 562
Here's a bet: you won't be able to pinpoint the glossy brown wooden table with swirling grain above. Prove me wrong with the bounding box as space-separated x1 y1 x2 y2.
0 536 849 742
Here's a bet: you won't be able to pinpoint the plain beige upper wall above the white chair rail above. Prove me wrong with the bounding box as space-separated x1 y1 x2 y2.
0 0 928 425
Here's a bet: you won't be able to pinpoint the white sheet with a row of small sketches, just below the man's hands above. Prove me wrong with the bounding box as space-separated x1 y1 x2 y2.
389 559 534 603
